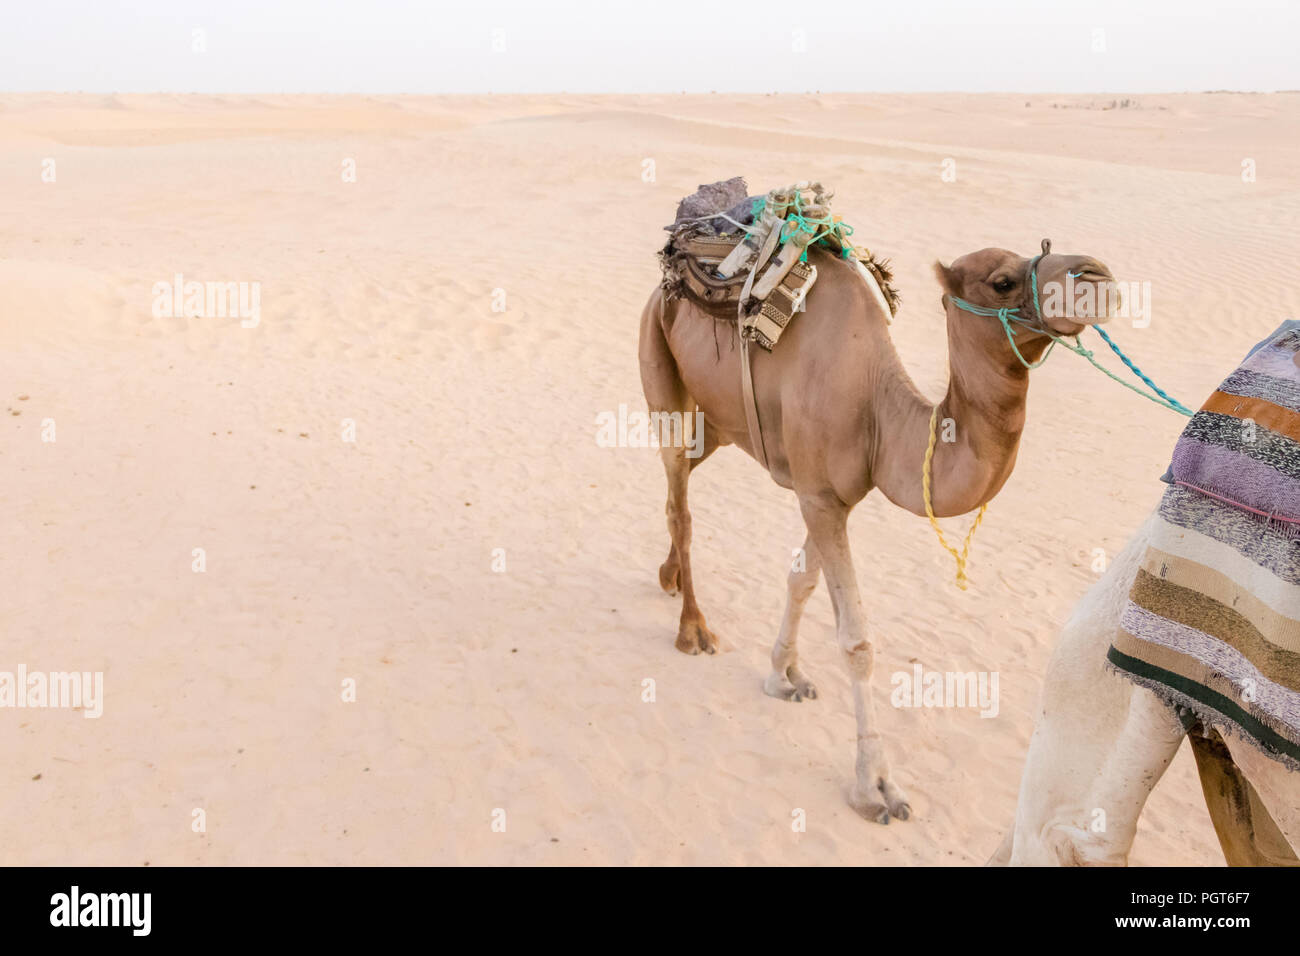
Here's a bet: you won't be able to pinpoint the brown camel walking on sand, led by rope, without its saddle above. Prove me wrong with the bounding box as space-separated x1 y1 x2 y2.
640 239 1114 823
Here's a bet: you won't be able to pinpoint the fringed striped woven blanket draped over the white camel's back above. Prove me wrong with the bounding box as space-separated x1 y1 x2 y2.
1108 329 1300 771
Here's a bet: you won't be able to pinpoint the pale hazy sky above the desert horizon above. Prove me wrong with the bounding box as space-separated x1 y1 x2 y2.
0 0 1300 92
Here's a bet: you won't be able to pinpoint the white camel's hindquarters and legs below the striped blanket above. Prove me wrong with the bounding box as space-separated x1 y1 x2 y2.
989 515 1300 866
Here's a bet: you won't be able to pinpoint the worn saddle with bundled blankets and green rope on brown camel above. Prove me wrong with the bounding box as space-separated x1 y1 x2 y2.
659 176 897 351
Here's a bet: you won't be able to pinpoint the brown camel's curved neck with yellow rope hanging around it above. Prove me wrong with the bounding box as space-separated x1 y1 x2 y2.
871 304 1047 516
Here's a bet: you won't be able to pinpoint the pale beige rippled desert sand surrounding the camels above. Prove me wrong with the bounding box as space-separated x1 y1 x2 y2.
0 94 1300 865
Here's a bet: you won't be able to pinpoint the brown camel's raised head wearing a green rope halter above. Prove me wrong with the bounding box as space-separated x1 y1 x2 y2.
935 239 1121 338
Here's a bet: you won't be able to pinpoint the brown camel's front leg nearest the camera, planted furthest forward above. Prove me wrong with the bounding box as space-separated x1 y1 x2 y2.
800 496 911 823
